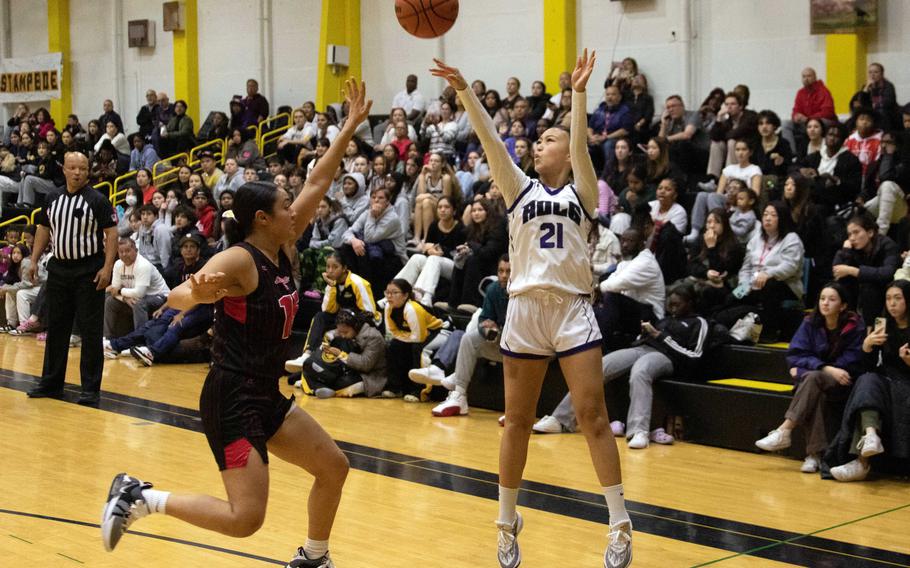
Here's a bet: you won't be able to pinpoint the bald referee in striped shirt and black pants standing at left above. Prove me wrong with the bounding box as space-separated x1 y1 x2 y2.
23 152 117 406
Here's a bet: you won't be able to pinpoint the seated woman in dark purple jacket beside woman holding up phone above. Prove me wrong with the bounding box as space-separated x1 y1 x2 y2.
755 282 866 473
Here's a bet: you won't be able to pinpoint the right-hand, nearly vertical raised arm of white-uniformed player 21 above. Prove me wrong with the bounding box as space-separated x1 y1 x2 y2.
569 48 598 215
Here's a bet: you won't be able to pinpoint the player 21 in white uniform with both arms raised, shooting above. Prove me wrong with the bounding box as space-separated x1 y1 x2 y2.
431 50 632 568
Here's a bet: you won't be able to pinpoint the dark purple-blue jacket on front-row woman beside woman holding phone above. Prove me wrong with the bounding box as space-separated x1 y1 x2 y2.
787 313 866 378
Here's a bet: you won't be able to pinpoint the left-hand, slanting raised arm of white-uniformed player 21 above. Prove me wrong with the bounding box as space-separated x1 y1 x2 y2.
430 59 532 206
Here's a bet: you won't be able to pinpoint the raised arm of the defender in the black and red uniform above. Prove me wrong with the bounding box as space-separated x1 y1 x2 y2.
291 77 373 238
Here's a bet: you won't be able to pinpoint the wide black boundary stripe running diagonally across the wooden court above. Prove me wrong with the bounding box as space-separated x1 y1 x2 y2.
0 369 910 568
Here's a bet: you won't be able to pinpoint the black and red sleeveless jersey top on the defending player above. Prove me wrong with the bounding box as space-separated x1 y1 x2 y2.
212 242 300 380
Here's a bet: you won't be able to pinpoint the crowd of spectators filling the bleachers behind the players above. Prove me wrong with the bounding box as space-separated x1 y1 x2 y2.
0 58 910 479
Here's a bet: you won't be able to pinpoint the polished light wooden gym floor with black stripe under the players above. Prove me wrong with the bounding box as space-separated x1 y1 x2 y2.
0 335 910 568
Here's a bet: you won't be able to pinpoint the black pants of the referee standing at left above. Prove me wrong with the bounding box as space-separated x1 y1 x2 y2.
39 255 104 394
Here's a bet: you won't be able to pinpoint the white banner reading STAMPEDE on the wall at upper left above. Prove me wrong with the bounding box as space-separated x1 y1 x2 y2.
0 53 63 103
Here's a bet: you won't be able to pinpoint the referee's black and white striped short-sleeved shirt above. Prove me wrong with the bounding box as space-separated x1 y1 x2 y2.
37 184 117 260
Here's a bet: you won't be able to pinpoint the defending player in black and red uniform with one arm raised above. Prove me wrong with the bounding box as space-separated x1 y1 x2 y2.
101 79 372 568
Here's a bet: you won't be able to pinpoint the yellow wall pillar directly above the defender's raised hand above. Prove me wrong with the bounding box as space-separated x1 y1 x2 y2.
316 0 361 109
